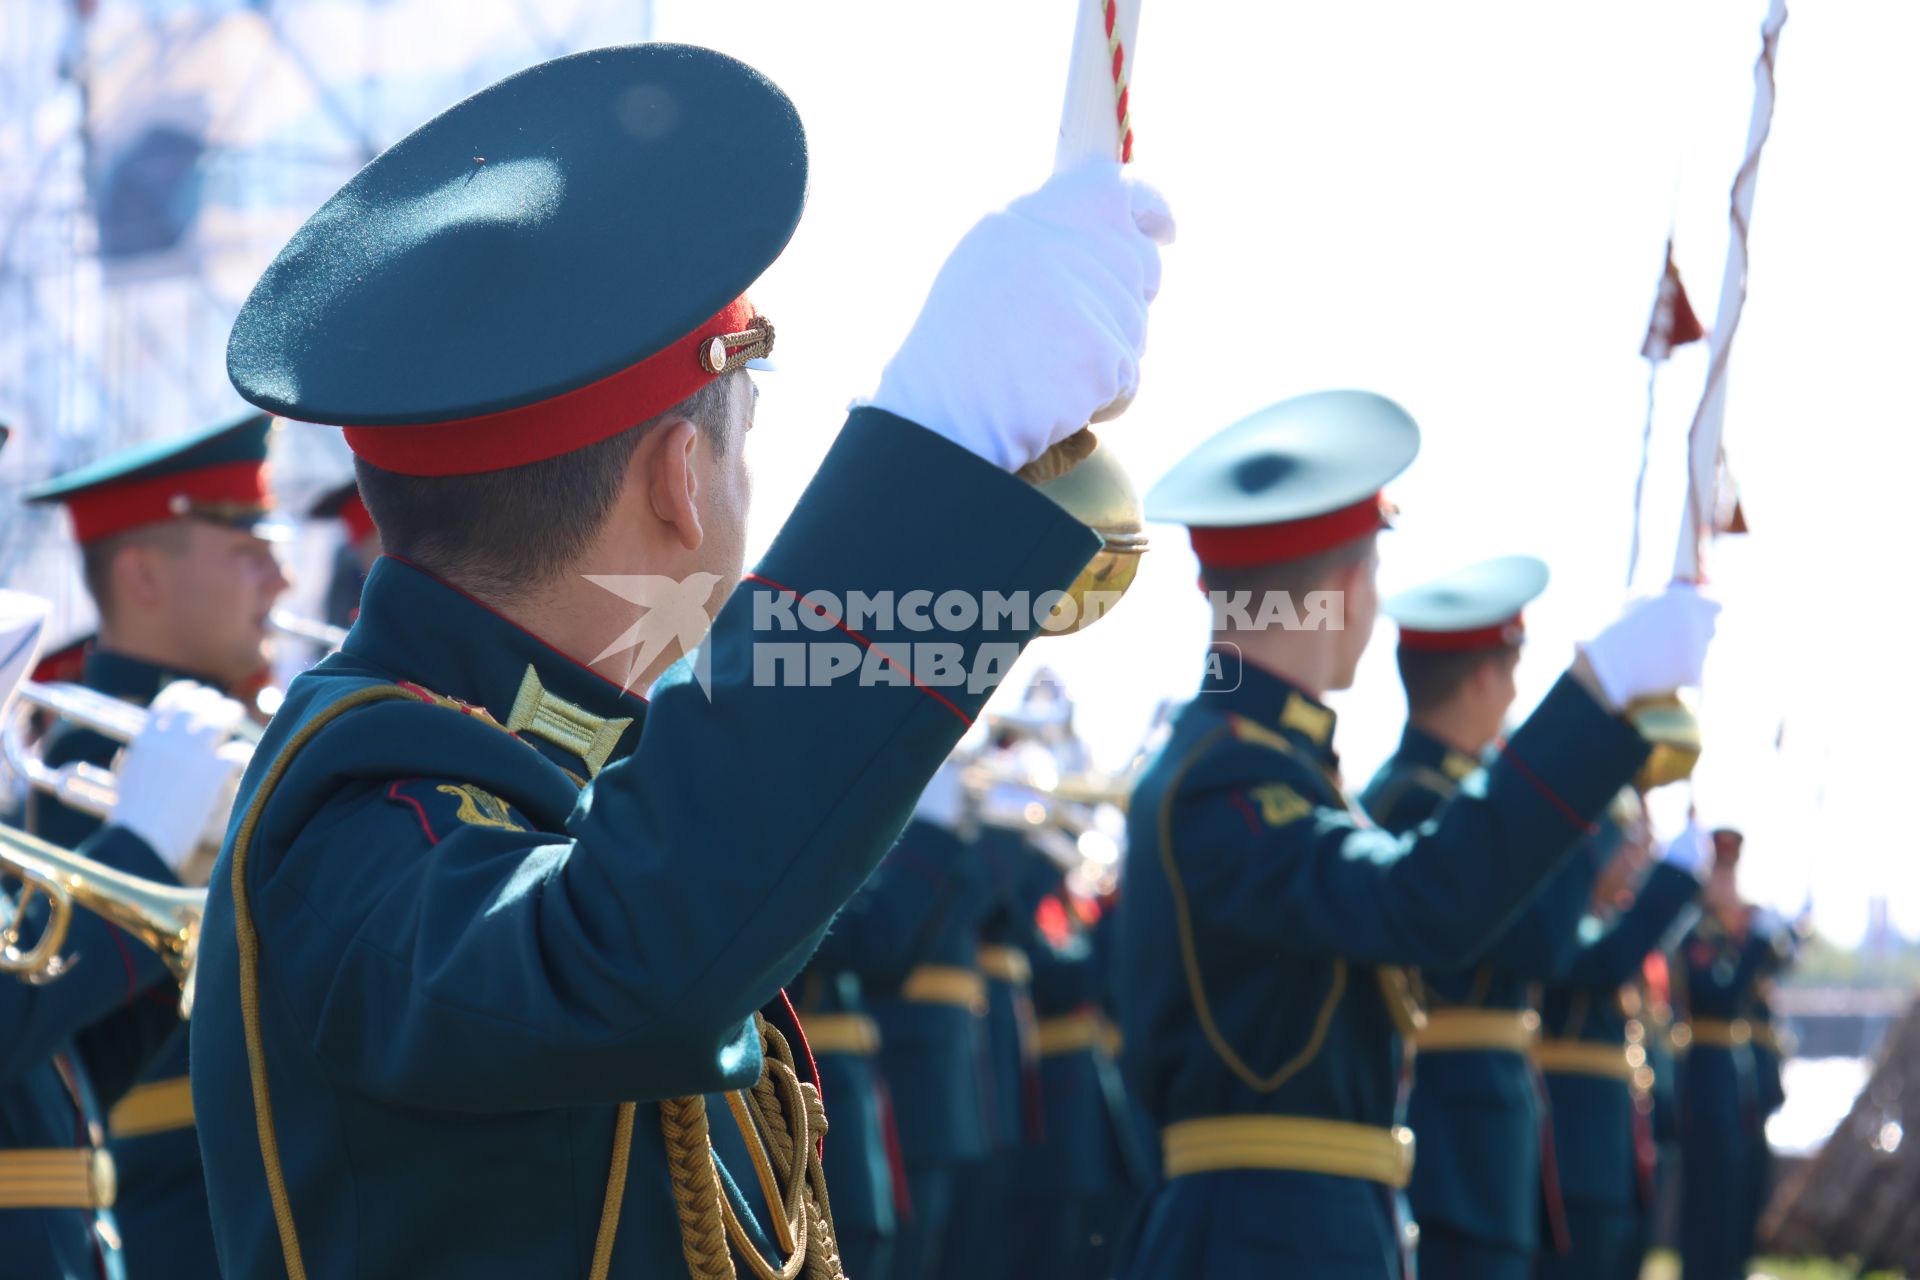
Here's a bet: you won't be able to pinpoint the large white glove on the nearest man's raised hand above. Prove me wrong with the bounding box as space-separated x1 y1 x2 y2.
872 161 1173 470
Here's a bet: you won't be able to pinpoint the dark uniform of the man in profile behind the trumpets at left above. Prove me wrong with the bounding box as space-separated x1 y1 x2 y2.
27 649 217 1280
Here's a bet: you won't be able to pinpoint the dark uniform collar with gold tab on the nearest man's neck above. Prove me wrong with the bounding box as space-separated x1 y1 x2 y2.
342 557 647 779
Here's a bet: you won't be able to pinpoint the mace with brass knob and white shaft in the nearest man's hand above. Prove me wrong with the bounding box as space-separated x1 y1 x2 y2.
1021 0 1146 635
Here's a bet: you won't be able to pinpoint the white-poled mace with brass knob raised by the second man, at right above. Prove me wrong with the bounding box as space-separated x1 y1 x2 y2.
1626 0 1788 789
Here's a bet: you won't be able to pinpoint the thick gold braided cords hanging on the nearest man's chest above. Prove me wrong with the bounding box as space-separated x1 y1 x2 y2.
660 1019 847 1280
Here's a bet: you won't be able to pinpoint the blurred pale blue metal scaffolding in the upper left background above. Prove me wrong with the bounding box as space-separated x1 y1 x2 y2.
0 0 653 639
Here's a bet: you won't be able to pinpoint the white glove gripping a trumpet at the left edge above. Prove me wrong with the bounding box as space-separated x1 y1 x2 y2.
109 679 246 871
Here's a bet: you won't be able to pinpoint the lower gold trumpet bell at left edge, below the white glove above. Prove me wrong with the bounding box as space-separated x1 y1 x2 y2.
0 825 207 1017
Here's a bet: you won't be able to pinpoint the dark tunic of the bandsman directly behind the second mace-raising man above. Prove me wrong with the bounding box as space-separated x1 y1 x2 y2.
1359 723 1601 1280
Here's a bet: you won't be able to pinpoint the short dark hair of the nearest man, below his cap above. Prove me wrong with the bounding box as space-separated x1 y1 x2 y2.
353 372 739 599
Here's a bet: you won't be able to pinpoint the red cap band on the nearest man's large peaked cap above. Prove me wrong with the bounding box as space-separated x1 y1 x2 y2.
344 296 755 476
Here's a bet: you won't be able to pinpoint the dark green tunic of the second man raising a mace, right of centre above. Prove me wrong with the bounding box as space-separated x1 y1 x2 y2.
1117 664 1647 1280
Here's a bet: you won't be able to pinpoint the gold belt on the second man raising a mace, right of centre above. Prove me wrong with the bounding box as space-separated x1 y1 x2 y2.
1160 1115 1413 1188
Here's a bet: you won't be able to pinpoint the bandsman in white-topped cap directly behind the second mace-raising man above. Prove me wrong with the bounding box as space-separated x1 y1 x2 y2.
1359 557 1597 1280
